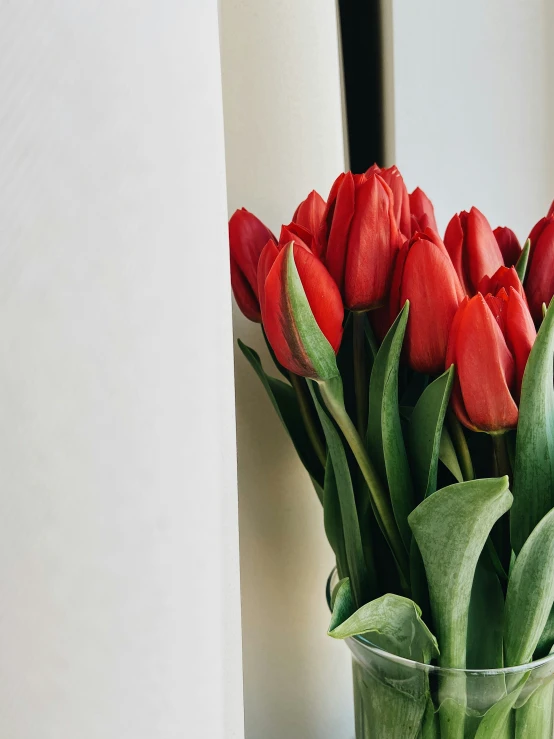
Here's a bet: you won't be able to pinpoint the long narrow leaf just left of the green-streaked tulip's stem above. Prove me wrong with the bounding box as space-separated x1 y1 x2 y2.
310 383 374 606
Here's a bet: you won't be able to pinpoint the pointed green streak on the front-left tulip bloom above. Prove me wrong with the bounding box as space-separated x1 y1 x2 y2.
286 245 339 380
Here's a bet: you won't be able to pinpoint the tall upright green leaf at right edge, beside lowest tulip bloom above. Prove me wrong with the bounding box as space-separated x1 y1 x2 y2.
510 301 554 554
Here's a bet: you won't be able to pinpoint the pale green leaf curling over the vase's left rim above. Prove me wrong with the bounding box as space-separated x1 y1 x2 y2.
329 593 439 663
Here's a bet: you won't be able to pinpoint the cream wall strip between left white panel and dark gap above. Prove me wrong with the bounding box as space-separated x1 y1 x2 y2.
221 0 354 739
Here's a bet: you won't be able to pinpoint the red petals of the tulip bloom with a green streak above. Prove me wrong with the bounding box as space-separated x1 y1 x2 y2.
260 243 344 379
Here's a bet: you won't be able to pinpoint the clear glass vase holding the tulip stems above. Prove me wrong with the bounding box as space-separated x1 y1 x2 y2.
327 573 554 739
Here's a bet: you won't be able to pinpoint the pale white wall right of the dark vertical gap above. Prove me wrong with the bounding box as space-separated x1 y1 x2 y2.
389 0 554 239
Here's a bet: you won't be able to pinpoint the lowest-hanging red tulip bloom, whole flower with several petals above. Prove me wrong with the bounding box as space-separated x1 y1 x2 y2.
446 287 535 433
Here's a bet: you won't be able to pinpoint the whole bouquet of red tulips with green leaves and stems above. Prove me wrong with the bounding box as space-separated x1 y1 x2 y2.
229 165 554 739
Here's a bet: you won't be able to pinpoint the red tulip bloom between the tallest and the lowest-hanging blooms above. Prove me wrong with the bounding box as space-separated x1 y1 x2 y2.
390 228 464 374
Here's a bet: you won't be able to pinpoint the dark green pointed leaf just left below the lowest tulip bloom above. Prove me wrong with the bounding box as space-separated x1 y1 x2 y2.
408 366 454 500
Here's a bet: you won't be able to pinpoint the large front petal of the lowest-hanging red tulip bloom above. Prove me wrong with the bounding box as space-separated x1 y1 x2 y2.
456 294 518 432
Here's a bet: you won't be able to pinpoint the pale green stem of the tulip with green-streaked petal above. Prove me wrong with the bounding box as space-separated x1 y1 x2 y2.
319 377 409 590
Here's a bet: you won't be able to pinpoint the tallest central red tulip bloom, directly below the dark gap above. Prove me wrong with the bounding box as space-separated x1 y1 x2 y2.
320 172 402 311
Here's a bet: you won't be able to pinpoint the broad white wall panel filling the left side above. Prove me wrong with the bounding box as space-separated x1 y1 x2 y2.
0 0 243 739
